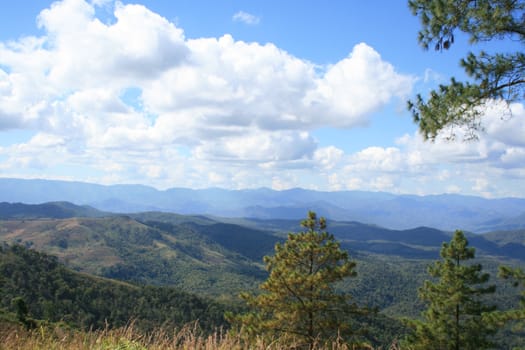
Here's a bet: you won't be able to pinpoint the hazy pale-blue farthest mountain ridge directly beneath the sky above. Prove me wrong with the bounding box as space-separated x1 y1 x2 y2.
0 178 525 233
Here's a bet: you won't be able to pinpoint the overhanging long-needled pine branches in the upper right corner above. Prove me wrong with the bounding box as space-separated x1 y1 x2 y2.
408 0 525 140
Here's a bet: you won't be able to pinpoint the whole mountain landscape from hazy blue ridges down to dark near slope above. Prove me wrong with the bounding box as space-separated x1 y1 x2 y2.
0 183 525 348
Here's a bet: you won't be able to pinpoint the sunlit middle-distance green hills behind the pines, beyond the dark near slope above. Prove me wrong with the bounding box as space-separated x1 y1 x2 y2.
0 204 525 324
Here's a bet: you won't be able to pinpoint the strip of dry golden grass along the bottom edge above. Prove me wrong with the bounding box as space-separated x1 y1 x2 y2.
0 324 396 350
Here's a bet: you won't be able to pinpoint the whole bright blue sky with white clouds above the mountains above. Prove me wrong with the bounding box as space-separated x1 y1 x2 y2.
0 0 525 198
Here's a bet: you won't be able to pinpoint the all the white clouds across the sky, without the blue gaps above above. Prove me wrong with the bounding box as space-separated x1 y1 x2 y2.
0 0 525 195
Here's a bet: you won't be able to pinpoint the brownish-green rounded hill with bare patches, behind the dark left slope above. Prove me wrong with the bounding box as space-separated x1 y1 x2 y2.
0 216 264 297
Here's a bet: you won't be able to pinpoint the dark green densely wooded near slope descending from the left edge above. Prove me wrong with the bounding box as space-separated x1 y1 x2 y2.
0 245 231 331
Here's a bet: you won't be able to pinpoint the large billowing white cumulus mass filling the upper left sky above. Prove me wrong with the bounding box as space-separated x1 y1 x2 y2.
0 0 412 162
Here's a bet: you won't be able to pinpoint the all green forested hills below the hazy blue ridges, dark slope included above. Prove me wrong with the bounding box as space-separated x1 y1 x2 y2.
0 203 525 348
